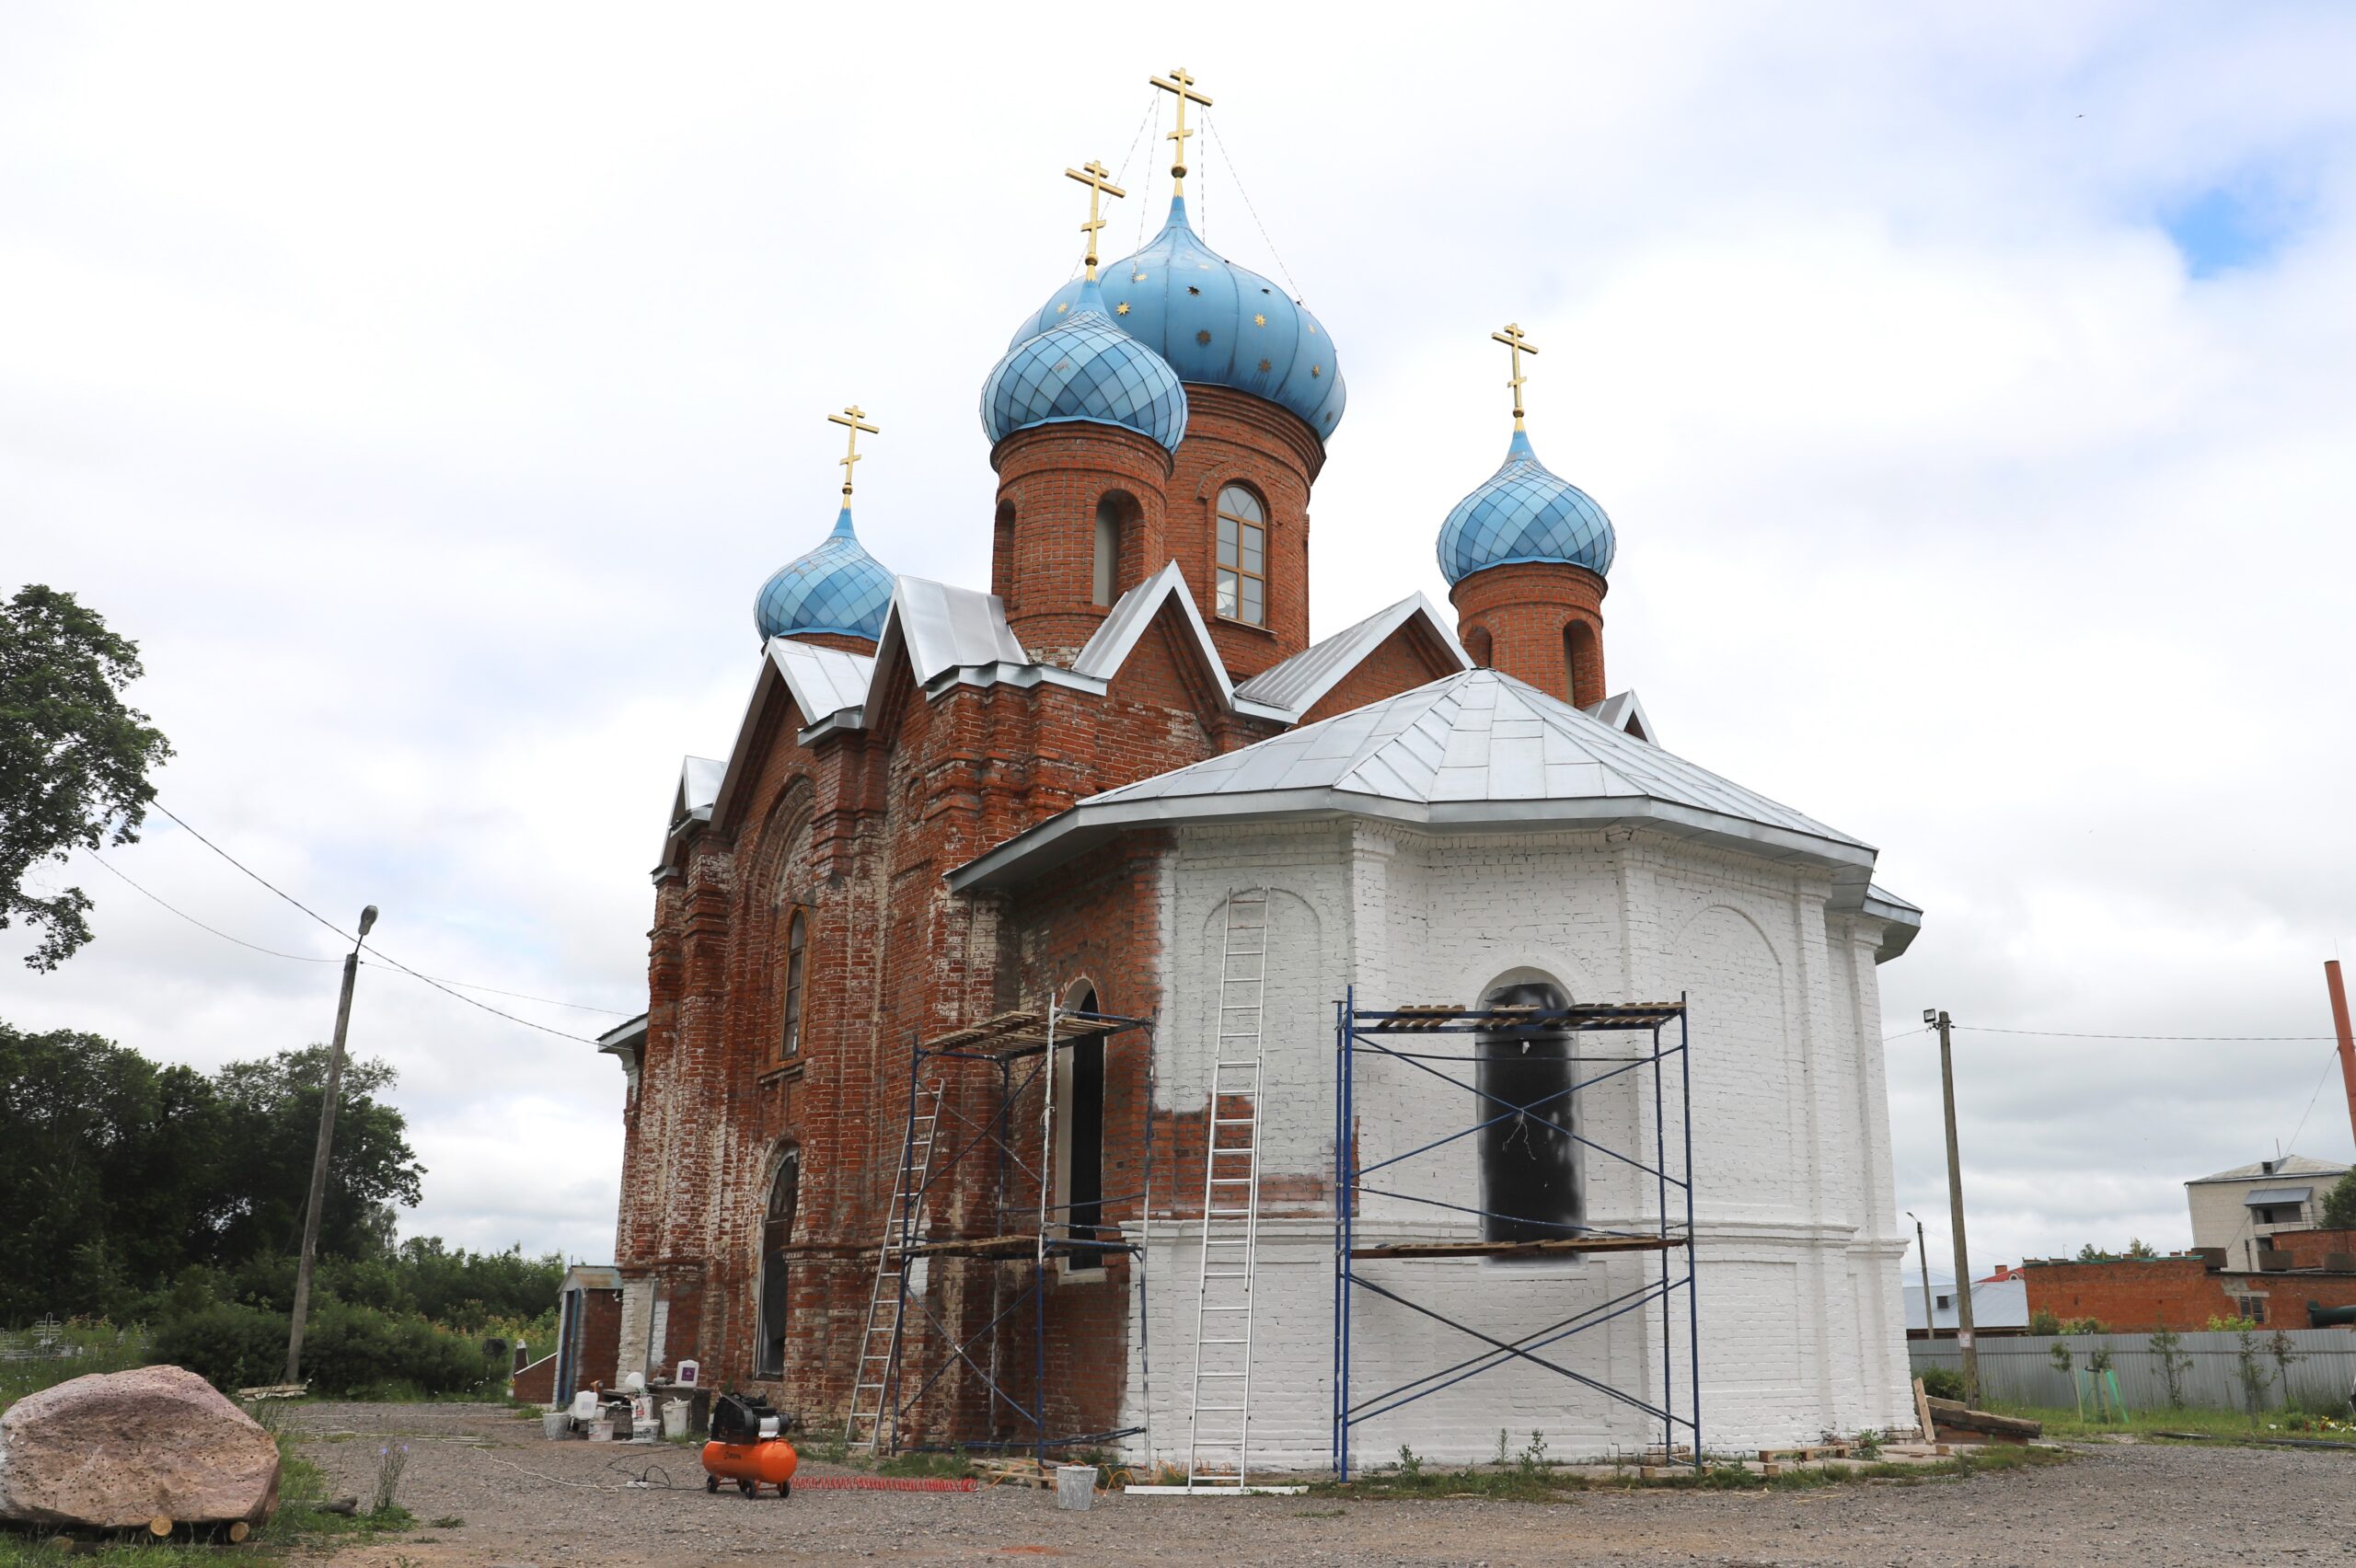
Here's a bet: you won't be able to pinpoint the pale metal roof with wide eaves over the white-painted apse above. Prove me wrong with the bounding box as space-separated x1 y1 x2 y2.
950 669 1876 909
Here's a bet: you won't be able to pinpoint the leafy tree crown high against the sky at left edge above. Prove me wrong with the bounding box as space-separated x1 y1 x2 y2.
0 584 172 970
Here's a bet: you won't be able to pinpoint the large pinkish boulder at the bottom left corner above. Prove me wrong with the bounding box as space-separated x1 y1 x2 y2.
0 1366 278 1530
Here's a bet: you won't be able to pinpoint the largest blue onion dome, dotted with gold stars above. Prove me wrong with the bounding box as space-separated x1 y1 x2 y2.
1015 195 1347 440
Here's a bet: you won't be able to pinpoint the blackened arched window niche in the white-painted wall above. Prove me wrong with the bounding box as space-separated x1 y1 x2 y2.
1472 973 1588 1240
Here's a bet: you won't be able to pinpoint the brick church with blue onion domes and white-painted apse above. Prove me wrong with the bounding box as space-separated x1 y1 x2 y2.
586 91 1920 1464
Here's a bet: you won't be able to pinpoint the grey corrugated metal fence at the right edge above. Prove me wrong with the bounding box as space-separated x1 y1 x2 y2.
1906 1328 2356 1411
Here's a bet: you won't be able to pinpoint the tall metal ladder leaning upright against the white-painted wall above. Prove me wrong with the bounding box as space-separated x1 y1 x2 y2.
1185 888 1267 1493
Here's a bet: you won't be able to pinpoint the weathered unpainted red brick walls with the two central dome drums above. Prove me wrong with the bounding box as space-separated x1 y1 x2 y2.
615 386 1456 1441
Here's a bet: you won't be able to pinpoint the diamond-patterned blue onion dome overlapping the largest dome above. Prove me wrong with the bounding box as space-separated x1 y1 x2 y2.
983 278 1185 452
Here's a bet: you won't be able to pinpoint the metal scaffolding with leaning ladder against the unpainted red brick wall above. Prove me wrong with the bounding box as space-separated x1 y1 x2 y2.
862 1000 1154 1462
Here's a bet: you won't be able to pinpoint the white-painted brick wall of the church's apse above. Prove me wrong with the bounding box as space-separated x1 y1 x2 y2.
1128 822 1913 1470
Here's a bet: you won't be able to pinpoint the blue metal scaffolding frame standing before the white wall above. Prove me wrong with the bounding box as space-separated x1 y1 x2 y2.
1334 986 1701 1481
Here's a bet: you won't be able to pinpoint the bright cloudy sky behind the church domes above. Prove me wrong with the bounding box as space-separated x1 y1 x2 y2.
0 3 2356 1272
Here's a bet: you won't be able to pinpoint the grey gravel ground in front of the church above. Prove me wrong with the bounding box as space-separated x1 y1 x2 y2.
287 1403 2356 1568
